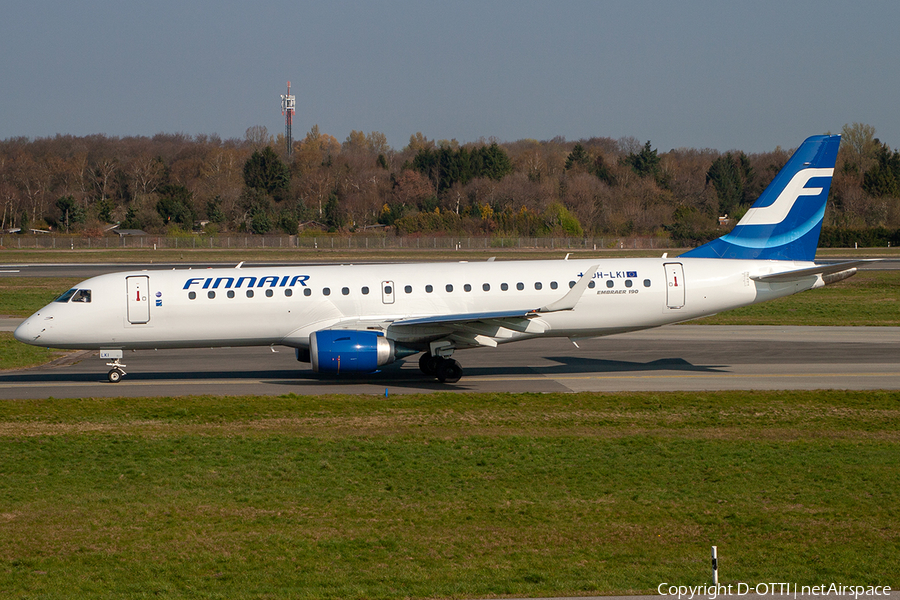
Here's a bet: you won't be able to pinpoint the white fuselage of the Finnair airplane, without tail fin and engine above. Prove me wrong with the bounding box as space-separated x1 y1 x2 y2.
16 258 823 349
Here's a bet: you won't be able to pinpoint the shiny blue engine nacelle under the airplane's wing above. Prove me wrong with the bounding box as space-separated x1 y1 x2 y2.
309 329 415 373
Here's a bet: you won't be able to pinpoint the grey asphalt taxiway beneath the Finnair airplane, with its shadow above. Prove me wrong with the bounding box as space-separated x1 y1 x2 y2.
0 320 900 399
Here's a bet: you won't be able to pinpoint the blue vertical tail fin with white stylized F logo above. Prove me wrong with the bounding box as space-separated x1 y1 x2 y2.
681 135 841 262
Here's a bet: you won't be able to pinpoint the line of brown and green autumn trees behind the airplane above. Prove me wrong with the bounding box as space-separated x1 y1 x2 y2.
0 123 900 244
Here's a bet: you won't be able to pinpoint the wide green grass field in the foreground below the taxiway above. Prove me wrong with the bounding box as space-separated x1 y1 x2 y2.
0 392 900 598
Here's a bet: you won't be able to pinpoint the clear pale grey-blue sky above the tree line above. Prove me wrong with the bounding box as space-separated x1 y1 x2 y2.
0 0 900 152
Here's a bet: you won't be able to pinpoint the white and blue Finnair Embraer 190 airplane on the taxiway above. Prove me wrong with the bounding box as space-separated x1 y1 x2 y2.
14 135 865 383
